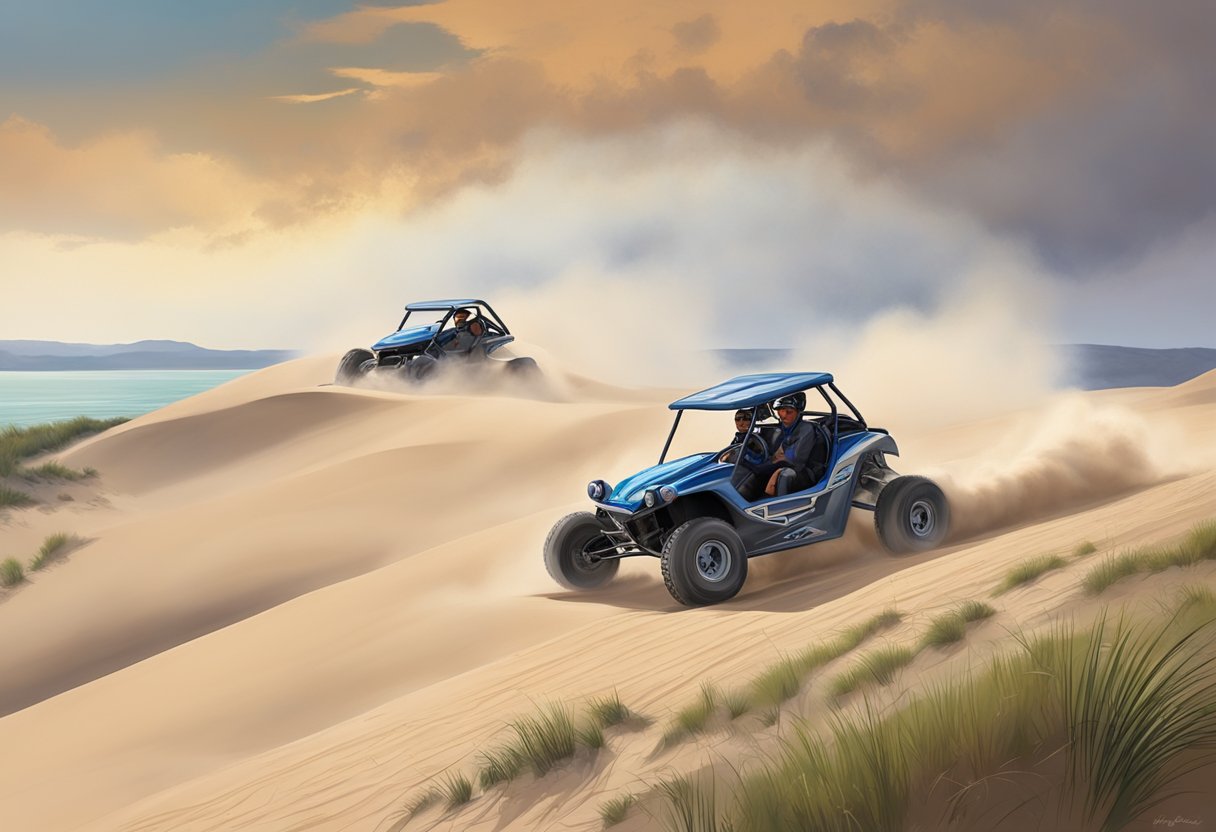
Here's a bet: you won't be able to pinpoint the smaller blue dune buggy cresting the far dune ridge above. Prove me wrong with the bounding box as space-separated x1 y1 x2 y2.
334 298 540 384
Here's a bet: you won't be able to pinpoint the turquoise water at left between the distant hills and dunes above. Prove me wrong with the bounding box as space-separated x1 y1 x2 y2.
0 370 252 427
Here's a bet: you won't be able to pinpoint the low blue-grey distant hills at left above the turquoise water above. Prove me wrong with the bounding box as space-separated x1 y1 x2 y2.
0 341 295 370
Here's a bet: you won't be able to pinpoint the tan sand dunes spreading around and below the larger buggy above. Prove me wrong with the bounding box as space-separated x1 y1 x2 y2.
0 358 1216 830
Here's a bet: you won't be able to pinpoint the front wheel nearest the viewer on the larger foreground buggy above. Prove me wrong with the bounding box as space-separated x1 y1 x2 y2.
662 517 748 607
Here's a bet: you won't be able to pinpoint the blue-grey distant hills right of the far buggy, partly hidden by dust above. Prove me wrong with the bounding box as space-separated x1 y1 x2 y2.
711 344 1216 390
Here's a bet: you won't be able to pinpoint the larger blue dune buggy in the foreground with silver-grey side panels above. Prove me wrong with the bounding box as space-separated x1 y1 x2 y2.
545 372 950 606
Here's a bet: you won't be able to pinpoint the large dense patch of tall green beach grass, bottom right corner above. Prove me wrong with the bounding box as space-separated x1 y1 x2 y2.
657 592 1216 832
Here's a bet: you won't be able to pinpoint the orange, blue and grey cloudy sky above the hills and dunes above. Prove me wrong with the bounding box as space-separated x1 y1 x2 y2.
0 0 1216 352
